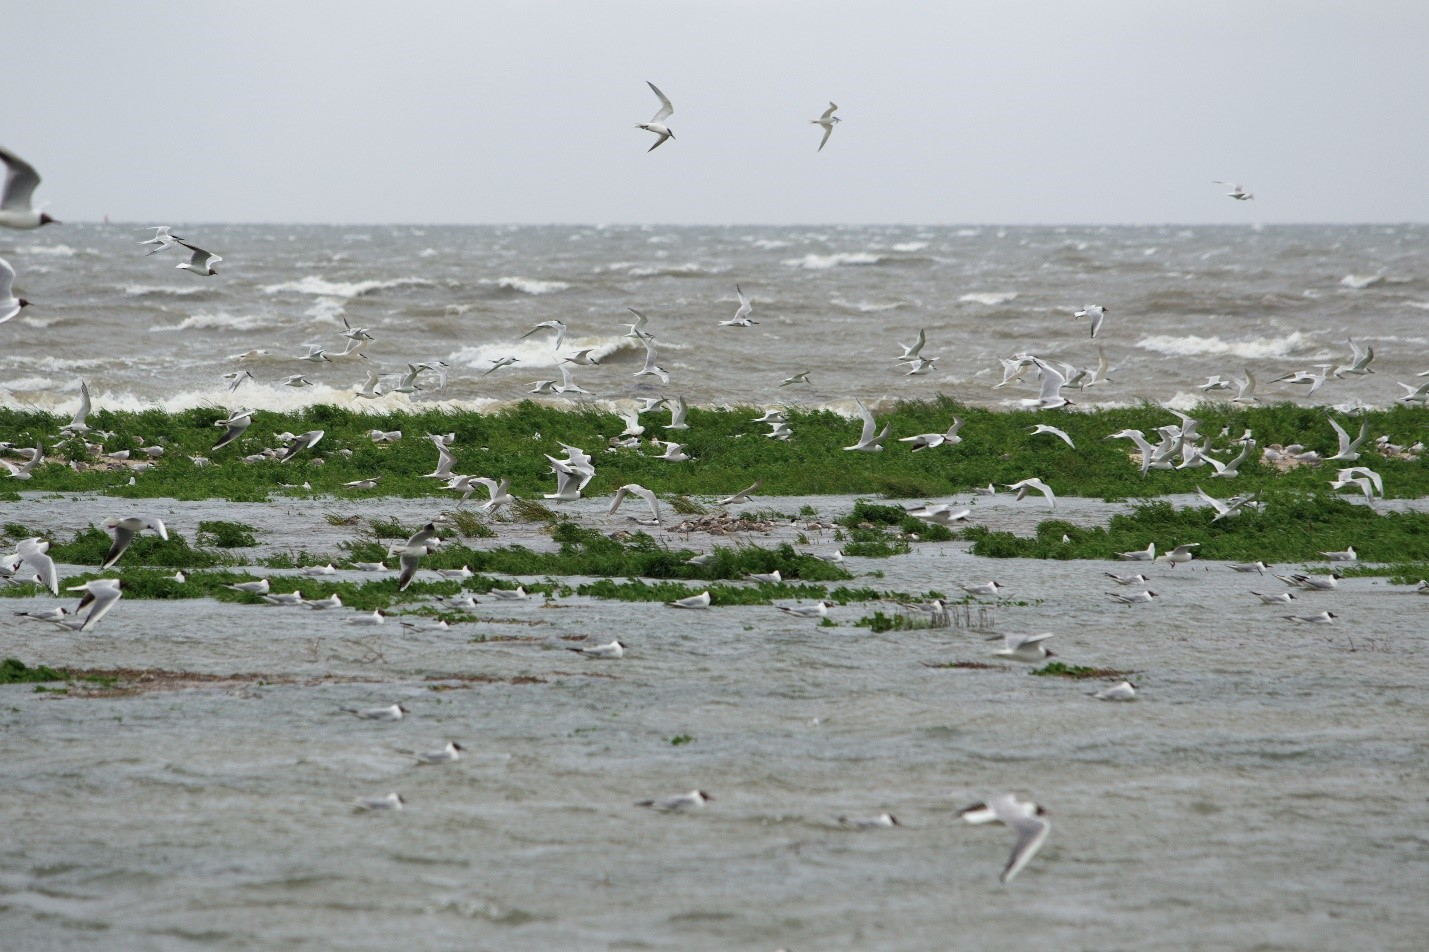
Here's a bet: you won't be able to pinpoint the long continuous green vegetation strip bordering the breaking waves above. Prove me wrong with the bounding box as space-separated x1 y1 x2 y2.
0 397 1429 500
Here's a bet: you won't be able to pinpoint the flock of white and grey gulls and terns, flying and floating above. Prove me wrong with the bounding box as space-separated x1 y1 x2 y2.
0 111 1429 883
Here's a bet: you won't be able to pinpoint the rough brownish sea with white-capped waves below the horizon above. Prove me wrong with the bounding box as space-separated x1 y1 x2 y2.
0 224 1429 410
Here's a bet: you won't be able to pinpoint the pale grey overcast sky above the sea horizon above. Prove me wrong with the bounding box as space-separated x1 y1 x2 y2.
11 0 1429 223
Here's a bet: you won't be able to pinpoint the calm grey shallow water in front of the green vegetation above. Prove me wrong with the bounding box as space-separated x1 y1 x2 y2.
0 495 1429 951
